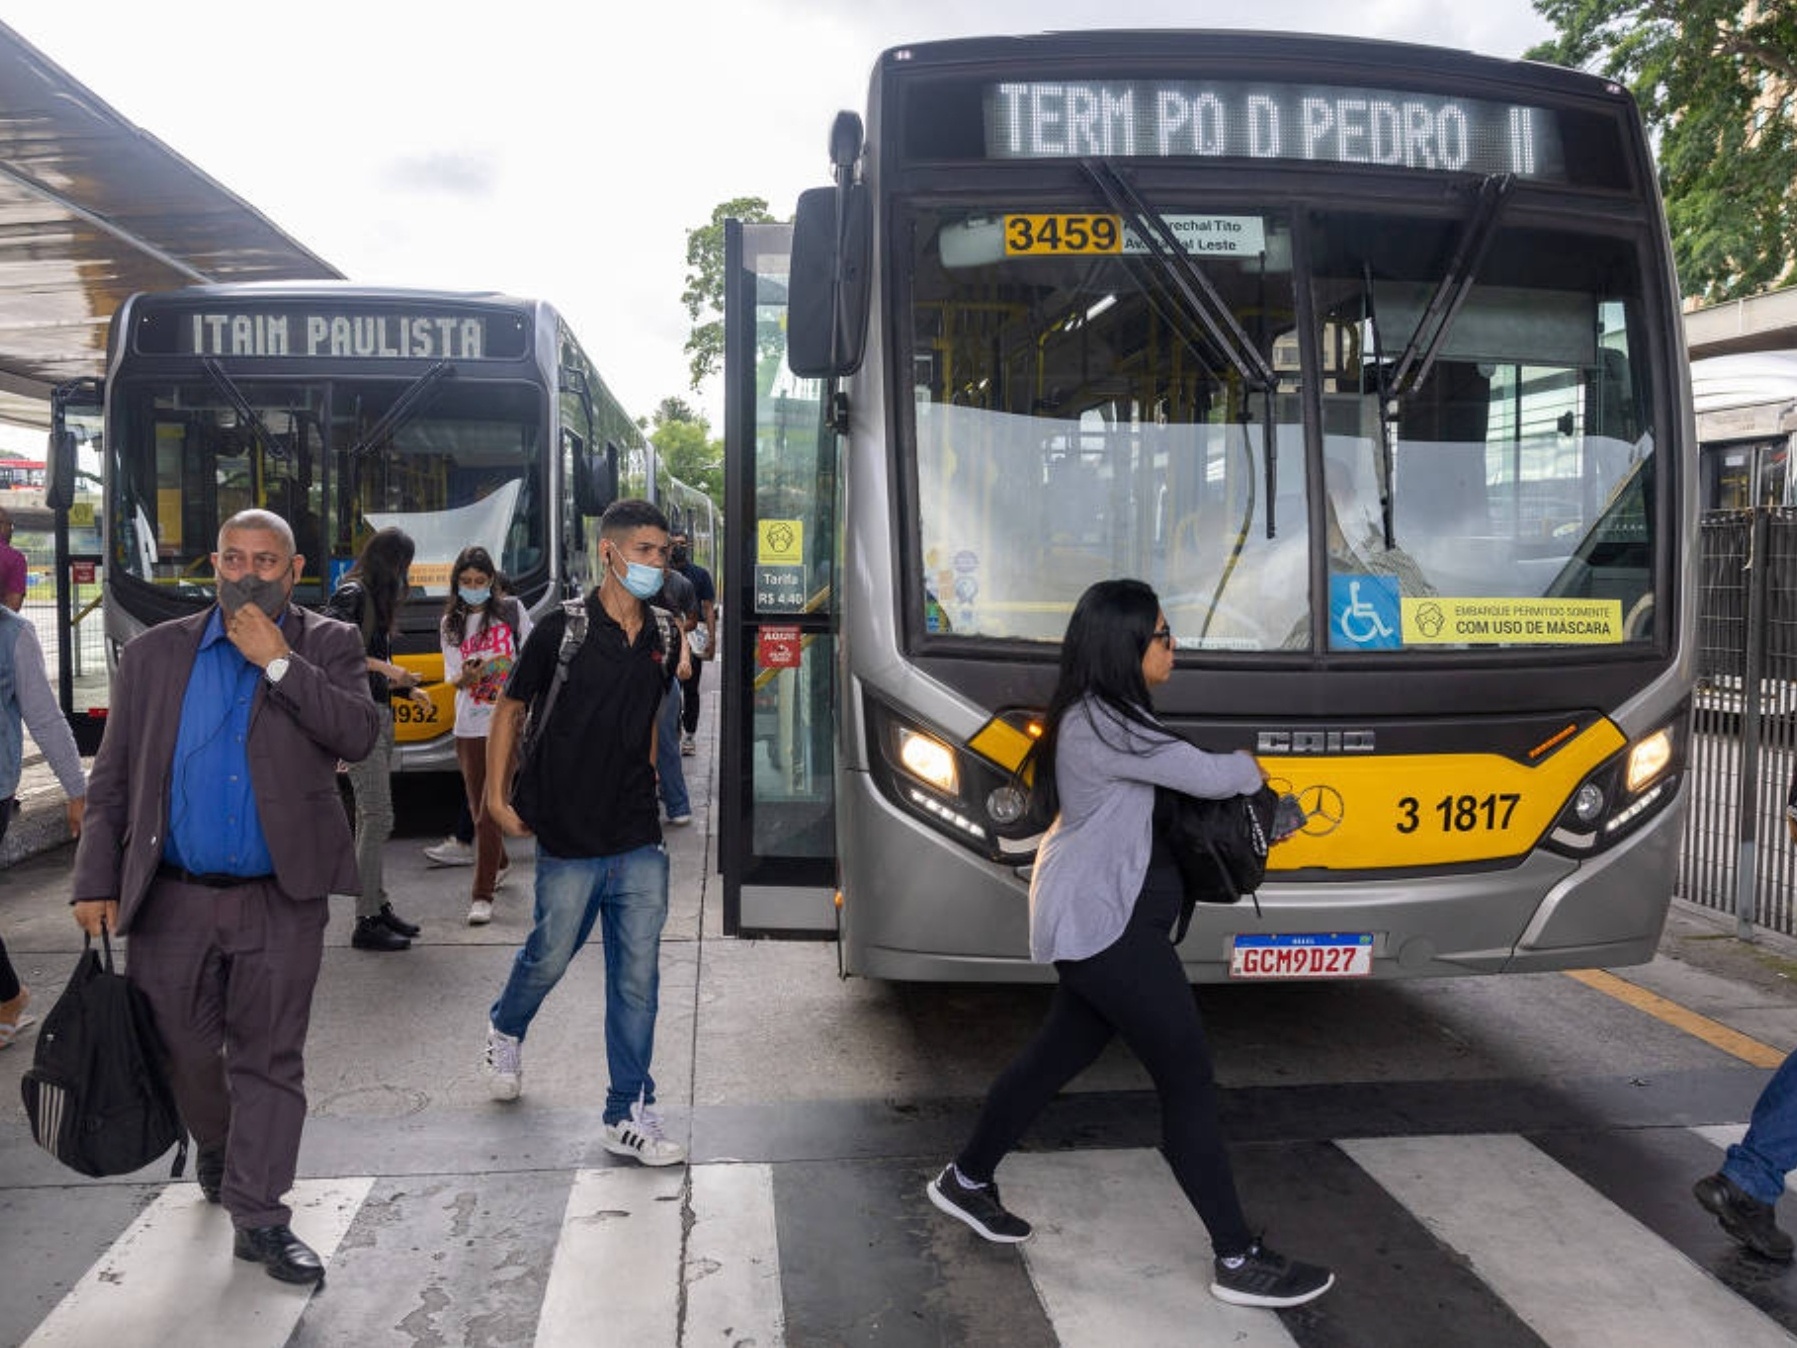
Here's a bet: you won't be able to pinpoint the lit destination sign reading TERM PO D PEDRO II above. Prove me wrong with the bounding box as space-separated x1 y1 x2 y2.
985 79 1565 180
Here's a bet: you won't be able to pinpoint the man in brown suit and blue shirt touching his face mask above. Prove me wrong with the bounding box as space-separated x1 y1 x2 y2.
74 510 381 1283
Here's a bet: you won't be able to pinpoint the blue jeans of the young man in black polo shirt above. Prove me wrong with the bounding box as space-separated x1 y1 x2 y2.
491 843 668 1123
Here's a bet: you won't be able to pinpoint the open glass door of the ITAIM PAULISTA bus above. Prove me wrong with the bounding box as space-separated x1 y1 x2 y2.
40 379 110 755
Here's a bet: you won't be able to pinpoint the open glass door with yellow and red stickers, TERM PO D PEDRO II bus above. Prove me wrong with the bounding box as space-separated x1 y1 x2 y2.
719 221 837 936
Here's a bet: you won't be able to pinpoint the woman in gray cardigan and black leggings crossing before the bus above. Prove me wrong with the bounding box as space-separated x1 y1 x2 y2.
929 581 1335 1307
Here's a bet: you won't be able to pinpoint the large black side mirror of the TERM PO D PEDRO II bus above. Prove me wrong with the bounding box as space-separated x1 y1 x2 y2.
787 183 873 379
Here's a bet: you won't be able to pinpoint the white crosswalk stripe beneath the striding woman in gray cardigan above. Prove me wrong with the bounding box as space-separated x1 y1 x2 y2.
999 1148 1294 1348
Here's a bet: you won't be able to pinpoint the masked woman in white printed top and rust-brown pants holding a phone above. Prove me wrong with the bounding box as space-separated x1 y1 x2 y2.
438 546 530 927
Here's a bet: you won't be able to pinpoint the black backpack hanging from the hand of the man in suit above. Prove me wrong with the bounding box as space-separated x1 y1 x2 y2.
20 927 187 1179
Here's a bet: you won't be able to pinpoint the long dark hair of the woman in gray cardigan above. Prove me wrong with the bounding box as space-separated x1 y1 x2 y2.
1017 581 1172 816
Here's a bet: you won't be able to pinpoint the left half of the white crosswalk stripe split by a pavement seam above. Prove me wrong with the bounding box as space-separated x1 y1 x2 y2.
531 1161 686 1348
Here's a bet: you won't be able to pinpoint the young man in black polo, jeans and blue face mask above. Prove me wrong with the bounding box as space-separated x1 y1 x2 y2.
485 501 686 1165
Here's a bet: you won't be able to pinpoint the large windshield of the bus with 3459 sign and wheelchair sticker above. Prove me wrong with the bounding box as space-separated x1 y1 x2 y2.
906 192 1655 652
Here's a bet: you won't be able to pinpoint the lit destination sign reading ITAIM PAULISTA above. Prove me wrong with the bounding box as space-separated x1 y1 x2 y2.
151 306 523 361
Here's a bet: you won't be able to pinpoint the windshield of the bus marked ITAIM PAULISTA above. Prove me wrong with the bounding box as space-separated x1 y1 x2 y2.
108 381 546 602
